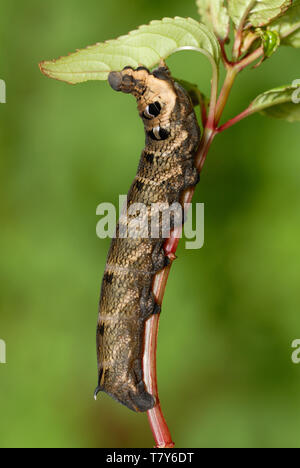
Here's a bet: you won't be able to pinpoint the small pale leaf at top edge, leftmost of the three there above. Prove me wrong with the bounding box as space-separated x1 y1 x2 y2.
196 0 230 39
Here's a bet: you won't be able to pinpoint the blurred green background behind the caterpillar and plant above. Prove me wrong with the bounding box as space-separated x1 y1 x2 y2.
0 0 300 447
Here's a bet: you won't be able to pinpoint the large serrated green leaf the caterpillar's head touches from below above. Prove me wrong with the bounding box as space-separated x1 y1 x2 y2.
40 17 220 84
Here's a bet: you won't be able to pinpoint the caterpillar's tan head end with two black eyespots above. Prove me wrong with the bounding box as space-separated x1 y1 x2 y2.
108 67 176 140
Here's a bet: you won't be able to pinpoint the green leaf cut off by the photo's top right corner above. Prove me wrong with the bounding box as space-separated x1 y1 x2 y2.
270 0 300 48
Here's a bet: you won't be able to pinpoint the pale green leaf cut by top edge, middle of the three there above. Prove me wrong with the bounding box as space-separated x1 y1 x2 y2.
228 0 292 27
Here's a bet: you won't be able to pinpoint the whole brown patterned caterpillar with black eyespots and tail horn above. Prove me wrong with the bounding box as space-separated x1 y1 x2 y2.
95 66 200 412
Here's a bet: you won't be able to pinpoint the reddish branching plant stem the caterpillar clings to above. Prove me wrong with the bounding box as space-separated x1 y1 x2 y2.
143 42 263 448
